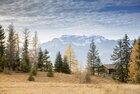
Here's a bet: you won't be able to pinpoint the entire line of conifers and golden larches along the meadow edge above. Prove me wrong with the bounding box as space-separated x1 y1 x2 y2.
0 24 140 83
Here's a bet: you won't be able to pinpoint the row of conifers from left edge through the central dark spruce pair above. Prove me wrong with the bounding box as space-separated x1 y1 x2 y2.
0 24 71 80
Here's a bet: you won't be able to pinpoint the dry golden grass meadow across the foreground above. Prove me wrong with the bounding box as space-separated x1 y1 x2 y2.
0 72 140 94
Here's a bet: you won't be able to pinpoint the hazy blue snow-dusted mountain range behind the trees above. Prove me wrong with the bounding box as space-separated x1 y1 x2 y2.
41 35 117 66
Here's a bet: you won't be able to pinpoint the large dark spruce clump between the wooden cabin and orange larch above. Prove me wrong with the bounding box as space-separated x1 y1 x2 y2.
112 35 131 82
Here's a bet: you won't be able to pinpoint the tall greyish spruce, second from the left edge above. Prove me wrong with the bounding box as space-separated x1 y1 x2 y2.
7 24 16 71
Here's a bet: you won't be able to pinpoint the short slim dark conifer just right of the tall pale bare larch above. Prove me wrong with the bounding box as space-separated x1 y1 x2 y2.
38 48 44 71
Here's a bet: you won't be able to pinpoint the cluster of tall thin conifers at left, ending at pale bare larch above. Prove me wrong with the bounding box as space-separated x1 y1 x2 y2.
0 24 41 77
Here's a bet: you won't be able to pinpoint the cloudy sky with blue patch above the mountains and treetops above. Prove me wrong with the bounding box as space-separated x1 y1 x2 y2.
0 0 140 42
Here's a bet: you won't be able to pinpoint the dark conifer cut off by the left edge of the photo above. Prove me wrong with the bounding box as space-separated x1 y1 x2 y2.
0 25 6 72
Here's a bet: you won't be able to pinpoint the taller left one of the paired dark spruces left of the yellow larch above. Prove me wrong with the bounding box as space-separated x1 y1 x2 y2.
55 52 63 72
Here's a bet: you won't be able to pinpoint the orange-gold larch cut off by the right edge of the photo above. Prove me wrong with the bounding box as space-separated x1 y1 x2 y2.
129 38 140 83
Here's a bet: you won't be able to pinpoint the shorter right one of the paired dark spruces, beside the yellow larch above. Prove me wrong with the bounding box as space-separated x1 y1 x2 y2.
62 56 71 74
